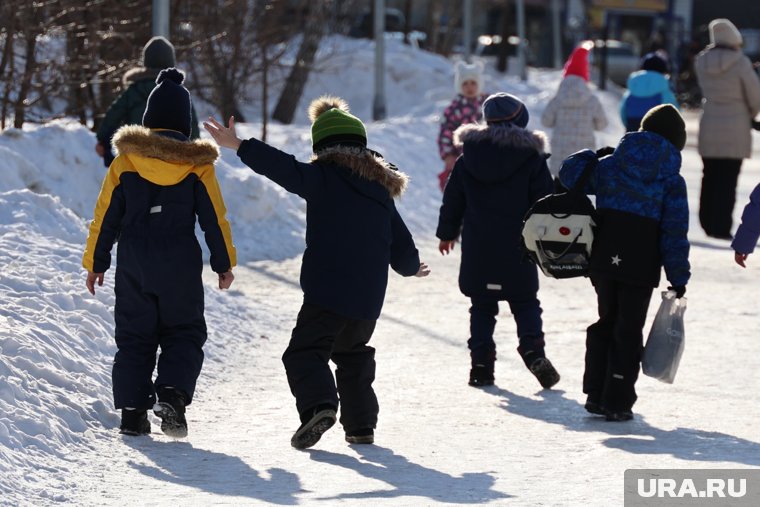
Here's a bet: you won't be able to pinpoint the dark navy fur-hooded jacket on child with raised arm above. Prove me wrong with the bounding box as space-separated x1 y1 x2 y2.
237 139 420 320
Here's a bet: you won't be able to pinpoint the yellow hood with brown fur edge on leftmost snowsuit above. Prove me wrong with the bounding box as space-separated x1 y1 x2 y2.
113 125 219 185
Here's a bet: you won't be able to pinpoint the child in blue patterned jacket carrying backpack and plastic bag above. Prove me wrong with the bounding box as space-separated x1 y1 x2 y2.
559 104 690 421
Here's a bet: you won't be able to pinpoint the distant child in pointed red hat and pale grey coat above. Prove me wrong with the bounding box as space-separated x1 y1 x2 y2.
541 43 607 178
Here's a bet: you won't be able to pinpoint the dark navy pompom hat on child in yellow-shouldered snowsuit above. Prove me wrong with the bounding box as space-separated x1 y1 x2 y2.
143 67 193 137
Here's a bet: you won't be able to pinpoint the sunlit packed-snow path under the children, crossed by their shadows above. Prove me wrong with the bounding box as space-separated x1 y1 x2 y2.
67 177 760 506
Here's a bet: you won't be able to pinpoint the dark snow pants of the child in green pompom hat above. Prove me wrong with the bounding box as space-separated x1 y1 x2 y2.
282 303 379 431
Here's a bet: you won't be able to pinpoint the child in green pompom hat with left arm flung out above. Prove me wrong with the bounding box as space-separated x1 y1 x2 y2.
204 97 429 449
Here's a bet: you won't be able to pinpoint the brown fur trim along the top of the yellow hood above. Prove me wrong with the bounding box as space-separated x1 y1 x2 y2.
113 125 219 166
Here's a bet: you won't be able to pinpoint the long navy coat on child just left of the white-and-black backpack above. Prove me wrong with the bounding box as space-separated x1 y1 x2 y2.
436 125 552 300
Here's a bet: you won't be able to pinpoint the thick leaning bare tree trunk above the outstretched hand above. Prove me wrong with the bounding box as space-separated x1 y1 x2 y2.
265 2 323 125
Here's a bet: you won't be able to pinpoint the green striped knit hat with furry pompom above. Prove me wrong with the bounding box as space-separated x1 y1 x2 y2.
309 95 367 153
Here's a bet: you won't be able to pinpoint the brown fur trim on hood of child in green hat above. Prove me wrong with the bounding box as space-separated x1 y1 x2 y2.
311 146 409 198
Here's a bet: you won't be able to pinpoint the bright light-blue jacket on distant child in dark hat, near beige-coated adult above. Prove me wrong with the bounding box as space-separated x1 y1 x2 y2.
620 70 678 132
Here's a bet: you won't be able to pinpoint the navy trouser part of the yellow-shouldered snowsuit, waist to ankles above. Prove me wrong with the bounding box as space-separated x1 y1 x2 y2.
112 234 206 409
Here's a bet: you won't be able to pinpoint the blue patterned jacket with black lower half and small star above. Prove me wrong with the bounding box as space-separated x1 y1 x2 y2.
559 132 690 287
